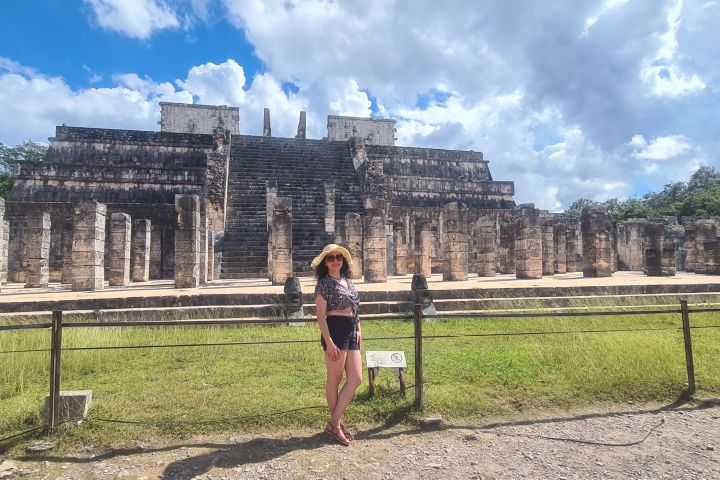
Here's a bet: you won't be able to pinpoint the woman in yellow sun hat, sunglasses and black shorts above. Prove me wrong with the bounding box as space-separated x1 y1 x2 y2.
311 243 362 445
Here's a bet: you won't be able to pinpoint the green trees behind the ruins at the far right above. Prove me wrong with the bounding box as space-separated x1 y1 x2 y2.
565 165 720 223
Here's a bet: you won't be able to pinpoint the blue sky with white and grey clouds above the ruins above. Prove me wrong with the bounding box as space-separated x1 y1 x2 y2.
0 0 720 211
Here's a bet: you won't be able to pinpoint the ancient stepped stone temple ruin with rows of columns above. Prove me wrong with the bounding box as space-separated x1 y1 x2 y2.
5 103 720 290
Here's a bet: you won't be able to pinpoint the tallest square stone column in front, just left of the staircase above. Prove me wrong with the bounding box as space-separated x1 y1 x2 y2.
175 195 201 288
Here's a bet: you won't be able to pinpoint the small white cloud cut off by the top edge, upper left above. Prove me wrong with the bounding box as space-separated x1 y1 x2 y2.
85 0 180 39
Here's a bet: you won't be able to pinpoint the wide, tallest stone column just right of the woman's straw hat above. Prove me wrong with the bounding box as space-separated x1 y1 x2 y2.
363 198 387 283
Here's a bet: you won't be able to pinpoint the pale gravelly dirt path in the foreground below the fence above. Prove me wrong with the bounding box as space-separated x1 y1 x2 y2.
5 403 720 480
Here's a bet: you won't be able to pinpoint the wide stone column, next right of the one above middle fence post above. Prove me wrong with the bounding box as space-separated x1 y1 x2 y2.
443 202 469 281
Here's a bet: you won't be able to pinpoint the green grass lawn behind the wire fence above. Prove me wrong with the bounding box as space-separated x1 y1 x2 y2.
0 313 720 446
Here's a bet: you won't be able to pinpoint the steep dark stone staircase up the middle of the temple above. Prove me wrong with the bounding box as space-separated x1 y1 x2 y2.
220 135 362 278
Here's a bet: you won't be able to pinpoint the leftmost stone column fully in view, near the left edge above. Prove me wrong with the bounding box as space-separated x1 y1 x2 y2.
25 212 50 287
